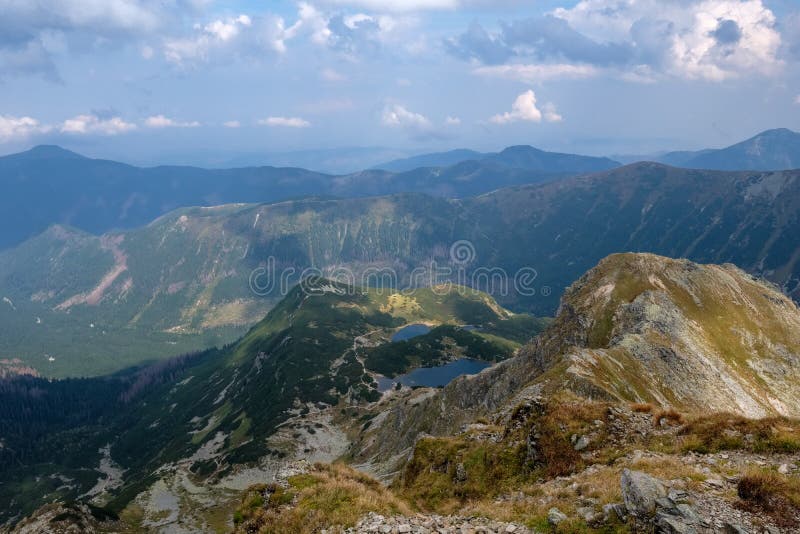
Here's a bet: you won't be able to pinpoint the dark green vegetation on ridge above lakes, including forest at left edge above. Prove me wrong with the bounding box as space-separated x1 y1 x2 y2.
0 279 535 528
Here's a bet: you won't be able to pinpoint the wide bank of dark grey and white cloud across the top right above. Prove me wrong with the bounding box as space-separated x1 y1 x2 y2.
445 0 783 83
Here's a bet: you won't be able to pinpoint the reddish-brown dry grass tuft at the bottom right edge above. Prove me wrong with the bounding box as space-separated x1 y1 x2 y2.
737 469 800 528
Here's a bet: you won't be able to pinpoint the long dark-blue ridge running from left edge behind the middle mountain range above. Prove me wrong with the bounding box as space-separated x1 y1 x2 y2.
0 146 611 249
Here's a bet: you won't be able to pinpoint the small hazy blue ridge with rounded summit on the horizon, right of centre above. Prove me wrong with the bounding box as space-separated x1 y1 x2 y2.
376 145 620 173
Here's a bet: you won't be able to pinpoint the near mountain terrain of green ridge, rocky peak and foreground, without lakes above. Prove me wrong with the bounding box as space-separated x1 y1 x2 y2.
6 254 800 532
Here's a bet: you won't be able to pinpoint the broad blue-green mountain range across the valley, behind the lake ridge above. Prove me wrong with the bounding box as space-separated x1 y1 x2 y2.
0 163 800 376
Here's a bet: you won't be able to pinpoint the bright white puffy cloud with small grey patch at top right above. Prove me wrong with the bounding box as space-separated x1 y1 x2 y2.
553 0 783 81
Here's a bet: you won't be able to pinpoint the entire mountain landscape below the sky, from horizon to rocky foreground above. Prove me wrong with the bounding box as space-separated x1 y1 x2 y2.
0 131 800 534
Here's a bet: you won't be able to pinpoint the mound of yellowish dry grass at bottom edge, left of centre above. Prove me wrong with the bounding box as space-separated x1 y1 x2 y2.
234 464 410 534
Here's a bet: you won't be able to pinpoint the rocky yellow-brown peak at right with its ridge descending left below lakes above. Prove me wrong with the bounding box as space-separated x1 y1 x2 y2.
356 254 800 475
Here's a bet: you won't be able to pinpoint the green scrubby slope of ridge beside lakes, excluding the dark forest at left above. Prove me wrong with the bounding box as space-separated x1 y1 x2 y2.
0 281 535 524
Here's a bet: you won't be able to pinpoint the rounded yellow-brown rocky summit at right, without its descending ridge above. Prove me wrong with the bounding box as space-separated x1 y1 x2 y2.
533 253 800 417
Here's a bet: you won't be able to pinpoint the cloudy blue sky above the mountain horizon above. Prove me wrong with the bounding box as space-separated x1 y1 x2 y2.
0 0 800 168
